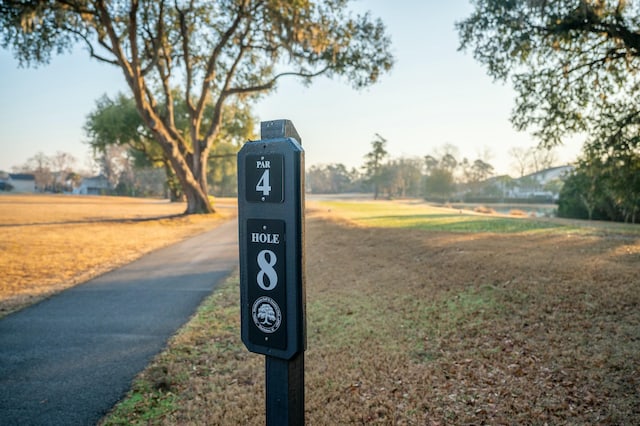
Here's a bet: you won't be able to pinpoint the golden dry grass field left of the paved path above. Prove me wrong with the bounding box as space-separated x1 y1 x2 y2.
0 195 235 316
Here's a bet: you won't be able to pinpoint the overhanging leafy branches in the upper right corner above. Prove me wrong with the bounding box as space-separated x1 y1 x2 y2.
457 0 640 154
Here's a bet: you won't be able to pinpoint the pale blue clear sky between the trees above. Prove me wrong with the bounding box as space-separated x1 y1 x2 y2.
0 0 580 175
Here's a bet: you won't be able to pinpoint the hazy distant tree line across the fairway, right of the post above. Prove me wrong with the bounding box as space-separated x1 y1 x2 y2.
306 134 558 202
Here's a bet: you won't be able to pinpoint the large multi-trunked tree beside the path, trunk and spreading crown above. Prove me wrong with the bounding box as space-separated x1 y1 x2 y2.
0 0 393 213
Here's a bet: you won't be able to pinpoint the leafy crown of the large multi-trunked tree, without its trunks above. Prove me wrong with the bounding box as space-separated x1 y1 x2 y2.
0 0 393 90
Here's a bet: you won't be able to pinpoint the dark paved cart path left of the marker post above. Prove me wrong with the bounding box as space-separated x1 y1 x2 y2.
0 220 238 426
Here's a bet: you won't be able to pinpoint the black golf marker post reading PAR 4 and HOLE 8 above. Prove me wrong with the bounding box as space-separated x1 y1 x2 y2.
238 120 307 426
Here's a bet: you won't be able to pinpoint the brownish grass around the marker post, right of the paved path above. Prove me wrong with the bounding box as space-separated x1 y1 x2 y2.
105 198 640 425
